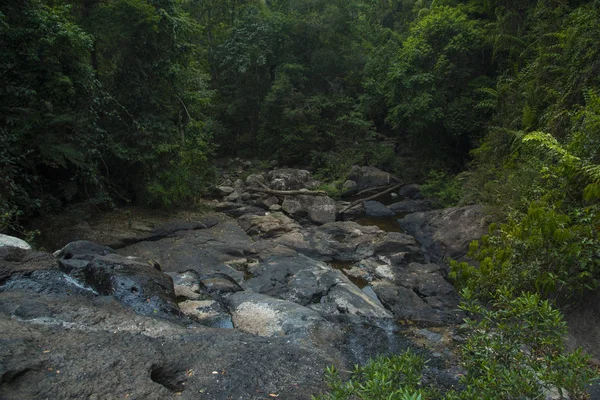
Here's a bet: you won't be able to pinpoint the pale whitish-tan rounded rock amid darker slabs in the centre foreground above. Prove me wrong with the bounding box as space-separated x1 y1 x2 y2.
226 292 332 338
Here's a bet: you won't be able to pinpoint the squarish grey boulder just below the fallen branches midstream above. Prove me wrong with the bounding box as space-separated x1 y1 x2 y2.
281 195 336 224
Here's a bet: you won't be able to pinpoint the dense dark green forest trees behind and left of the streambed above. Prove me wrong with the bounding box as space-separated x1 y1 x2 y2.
0 0 496 228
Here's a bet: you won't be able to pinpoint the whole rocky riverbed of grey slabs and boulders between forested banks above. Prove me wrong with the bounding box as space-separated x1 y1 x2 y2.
0 167 548 399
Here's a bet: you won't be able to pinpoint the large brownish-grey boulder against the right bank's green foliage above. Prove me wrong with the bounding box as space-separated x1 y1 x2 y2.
398 205 487 262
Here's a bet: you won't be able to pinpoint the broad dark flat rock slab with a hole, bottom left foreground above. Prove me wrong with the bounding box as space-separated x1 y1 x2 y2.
0 291 332 400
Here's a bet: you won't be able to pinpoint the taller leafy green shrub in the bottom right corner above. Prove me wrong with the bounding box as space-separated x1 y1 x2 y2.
447 288 597 400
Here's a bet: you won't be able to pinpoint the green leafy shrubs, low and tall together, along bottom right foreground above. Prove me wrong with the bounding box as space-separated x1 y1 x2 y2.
315 288 597 400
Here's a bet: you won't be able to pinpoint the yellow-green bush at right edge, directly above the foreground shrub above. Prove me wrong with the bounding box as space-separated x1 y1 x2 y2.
450 203 600 300
